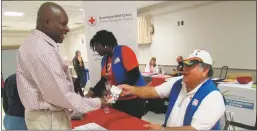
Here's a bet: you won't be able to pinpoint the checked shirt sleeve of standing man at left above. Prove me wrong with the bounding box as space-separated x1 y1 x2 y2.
32 53 101 113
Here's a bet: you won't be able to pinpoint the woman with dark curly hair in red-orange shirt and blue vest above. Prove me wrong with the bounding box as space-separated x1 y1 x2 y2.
86 30 146 118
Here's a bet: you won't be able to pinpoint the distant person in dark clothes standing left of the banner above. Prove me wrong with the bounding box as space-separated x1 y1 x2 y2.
72 50 85 88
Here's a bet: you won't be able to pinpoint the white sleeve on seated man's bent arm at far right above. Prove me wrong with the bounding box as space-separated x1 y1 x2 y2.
191 91 226 130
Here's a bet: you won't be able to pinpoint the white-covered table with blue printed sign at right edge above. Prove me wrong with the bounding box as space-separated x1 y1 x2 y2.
218 82 256 129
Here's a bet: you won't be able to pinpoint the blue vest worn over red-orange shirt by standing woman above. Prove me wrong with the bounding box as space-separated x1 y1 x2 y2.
101 46 146 86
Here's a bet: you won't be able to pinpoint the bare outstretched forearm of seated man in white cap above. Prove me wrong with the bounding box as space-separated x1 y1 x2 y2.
131 86 159 99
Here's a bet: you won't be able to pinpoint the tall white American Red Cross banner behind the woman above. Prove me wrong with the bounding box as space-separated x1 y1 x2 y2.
83 1 137 87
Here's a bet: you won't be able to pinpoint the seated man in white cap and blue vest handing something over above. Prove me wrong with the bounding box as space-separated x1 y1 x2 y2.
119 50 225 130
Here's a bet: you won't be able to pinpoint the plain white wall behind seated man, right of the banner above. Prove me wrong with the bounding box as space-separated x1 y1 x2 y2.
138 1 256 69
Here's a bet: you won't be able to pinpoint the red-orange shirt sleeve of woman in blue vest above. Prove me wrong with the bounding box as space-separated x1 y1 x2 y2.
122 46 139 71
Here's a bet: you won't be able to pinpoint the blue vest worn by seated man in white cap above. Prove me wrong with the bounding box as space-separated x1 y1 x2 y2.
163 79 221 130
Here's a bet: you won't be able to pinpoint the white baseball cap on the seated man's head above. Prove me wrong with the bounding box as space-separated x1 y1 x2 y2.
183 49 213 66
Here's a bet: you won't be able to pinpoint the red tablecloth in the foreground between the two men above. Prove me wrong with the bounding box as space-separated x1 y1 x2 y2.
71 108 148 130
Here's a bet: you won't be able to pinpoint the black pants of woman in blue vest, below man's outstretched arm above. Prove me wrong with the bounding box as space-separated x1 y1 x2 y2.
113 98 146 119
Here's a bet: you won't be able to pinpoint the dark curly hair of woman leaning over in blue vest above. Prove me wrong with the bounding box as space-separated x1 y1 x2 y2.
90 30 118 51
